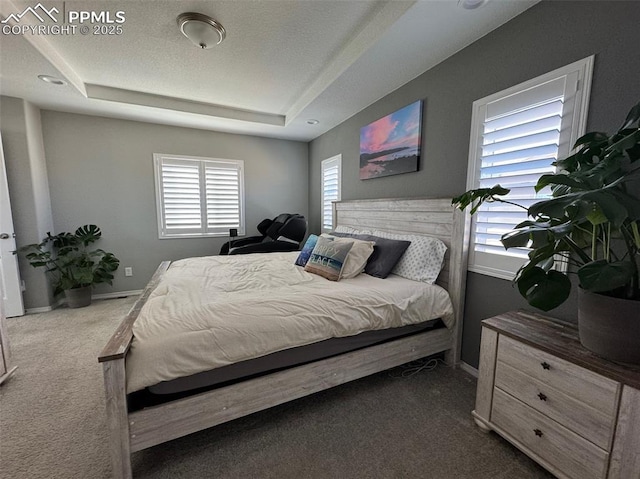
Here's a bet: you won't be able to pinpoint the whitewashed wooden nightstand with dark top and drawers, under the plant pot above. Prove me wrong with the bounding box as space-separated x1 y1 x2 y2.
473 312 640 479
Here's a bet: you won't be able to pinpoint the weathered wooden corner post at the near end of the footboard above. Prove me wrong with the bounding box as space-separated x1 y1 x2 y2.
102 359 131 479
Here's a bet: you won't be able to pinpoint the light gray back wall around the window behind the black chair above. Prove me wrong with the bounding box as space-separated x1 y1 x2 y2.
20 111 308 307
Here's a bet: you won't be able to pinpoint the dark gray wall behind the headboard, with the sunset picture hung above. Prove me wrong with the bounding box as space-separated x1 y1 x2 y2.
309 1 640 366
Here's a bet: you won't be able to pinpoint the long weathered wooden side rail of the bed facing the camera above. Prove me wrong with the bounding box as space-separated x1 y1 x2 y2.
127 328 452 452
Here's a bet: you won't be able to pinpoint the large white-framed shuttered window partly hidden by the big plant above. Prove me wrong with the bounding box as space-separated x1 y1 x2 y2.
467 57 593 279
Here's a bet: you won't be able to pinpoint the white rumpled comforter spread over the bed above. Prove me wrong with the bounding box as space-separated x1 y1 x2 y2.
126 253 453 392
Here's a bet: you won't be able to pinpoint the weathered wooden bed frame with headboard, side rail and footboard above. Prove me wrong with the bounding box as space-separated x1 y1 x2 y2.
98 198 469 478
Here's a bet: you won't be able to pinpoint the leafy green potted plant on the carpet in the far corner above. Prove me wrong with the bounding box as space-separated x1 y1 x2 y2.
19 225 120 308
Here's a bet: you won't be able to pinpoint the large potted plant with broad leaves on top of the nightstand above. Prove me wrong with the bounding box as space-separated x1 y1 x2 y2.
453 103 640 364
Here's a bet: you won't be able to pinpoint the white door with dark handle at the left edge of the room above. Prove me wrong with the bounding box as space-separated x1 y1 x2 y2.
0 135 24 317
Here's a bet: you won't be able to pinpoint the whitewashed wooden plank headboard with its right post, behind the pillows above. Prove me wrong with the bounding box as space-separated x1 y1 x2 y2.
333 198 469 363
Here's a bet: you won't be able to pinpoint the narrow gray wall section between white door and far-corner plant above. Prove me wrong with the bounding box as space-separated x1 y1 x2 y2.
0 96 53 308
